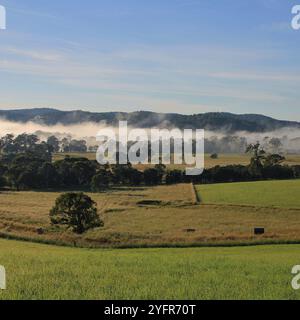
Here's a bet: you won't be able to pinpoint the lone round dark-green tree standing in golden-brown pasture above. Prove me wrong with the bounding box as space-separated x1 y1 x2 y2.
50 192 103 234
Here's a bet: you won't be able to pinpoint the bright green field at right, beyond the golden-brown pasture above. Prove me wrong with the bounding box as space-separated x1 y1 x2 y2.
197 180 300 209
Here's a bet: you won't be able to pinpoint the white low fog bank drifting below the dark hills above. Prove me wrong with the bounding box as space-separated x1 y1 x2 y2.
0 119 300 153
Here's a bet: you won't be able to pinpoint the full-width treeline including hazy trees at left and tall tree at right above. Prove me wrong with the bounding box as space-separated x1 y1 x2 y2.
0 134 300 192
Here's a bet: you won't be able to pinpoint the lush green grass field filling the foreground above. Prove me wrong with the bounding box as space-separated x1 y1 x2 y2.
0 240 300 300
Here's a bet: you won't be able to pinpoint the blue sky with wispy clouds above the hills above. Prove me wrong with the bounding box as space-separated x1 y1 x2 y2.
0 0 300 121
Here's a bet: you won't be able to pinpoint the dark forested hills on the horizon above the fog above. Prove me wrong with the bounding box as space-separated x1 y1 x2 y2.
0 108 300 133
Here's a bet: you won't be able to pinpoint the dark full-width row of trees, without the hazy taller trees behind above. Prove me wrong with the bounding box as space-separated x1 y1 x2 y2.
0 154 300 192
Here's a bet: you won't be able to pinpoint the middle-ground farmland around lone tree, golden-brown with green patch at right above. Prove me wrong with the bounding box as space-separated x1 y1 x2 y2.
0 180 300 247
